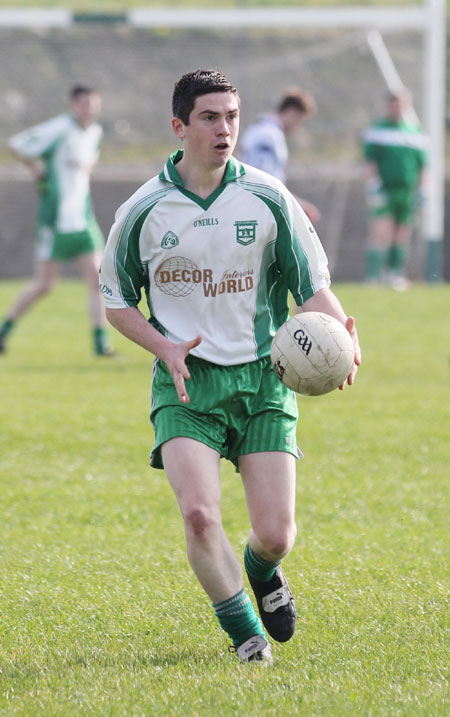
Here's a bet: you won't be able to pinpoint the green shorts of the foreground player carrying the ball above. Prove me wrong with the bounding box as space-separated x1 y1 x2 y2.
150 356 302 469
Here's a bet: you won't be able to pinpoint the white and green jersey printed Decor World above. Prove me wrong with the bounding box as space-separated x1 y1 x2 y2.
100 151 330 365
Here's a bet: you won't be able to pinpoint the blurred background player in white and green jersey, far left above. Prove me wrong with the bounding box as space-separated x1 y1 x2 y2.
0 85 112 356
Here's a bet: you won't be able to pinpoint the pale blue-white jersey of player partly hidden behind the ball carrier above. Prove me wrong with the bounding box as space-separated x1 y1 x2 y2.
240 115 288 182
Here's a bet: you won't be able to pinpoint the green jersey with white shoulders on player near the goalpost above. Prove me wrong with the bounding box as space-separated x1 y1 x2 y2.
363 119 427 190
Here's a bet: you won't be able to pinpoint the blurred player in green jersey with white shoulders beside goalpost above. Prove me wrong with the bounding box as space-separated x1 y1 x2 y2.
363 89 426 290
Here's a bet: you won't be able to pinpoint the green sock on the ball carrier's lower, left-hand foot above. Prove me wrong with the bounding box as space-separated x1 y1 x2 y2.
213 588 267 647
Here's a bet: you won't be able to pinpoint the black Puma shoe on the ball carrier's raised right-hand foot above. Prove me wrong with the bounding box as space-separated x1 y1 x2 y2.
247 566 297 642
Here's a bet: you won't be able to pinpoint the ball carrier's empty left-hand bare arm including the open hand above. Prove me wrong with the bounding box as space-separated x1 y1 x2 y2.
106 306 202 403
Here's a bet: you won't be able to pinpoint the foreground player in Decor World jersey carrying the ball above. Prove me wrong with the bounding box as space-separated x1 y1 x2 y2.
100 70 360 661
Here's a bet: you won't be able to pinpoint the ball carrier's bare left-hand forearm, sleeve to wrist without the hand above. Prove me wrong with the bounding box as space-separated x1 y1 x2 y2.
106 306 173 361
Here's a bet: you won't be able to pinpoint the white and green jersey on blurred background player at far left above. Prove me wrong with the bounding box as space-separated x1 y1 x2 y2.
9 113 103 234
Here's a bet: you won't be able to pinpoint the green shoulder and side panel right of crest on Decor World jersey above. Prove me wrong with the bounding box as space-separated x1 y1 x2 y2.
237 179 314 356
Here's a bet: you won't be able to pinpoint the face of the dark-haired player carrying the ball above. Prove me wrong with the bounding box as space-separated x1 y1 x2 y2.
173 92 239 169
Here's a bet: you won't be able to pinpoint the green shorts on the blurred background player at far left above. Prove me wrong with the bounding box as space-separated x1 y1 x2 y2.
36 221 105 261
